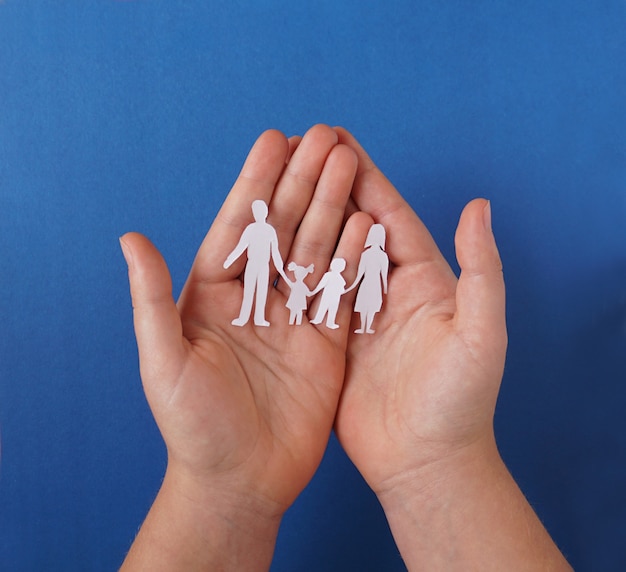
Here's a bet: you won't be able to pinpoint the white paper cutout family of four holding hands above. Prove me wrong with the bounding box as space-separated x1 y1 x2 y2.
224 200 389 334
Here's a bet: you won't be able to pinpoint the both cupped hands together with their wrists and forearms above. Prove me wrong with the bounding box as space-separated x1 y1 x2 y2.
121 125 569 572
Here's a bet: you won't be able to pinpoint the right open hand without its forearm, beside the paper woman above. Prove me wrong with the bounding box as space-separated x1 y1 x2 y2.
336 129 506 493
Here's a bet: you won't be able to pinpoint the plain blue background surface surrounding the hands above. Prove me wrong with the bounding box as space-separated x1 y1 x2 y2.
0 0 626 572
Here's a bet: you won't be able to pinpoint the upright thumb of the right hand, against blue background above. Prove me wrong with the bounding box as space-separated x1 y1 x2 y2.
455 199 507 363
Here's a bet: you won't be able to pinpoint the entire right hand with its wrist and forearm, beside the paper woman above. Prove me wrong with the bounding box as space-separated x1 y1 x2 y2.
335 129 571 571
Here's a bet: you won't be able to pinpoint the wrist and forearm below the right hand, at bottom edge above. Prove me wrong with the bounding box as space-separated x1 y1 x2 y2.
370 434 571 571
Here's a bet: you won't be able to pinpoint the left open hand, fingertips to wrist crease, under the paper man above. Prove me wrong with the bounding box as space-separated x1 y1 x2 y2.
122 126 362 512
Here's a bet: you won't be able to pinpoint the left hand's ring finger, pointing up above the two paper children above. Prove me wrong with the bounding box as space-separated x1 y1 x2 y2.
278 145 357 290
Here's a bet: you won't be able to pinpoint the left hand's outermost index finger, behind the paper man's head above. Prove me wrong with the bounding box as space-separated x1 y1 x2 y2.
184 130 288 282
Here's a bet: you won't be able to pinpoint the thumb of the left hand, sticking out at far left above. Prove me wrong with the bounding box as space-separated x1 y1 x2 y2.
120 232 185 391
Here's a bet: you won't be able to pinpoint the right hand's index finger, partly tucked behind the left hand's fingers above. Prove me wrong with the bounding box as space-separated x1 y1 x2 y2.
335 127 443 266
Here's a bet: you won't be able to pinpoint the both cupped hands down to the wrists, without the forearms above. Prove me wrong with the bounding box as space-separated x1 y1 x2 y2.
121 125 506 564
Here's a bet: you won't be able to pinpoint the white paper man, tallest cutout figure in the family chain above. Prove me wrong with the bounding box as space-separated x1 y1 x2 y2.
224 200 284 326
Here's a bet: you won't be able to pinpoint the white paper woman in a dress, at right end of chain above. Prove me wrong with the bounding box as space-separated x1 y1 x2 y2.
346 224 389 334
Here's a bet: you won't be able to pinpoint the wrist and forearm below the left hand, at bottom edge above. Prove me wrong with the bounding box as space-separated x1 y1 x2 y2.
121 463 282 572
